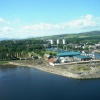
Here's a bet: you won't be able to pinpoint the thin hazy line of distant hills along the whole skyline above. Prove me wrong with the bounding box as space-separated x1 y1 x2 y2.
0 31 100 41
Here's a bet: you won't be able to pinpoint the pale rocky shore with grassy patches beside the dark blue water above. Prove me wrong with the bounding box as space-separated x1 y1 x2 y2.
9 60 100 79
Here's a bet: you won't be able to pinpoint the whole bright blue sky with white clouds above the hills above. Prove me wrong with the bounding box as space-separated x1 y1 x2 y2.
0 0 100 39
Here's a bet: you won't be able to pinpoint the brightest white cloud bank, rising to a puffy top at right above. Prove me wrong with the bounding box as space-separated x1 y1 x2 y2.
22 15 99 32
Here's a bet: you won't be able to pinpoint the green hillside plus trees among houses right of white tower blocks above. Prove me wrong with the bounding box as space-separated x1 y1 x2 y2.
38 31 100 52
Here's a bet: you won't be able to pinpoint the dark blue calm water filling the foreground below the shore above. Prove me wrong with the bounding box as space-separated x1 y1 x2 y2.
0 66 100 100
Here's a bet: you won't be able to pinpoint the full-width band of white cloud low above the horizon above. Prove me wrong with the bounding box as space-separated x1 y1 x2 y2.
0 14 100 38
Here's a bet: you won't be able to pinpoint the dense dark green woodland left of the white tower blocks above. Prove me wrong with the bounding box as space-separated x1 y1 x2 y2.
0 39 46 60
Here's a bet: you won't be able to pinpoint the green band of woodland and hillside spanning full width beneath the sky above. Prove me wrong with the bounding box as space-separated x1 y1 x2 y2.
0 31 100 60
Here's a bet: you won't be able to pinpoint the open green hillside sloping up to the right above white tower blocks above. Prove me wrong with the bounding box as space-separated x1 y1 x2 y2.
38 31 100 43
